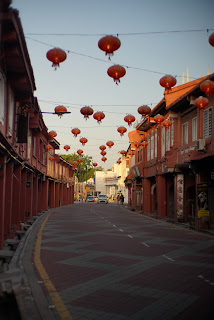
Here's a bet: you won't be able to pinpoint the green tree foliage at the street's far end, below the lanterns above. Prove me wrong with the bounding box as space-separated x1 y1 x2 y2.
60 153 103 182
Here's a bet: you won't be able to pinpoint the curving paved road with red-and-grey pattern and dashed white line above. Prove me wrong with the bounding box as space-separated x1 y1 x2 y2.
30 203 214 320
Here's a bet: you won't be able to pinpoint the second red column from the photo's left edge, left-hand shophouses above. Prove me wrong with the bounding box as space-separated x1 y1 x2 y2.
4 162 13 237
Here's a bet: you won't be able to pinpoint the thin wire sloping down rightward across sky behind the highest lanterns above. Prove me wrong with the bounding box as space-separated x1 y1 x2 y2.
26 35 197 80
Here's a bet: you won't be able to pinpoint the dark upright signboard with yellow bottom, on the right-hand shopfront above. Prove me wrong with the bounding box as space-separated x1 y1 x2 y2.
198 183 210 218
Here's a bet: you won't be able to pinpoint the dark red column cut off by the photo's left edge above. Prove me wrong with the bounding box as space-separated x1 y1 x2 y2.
0 156 6 248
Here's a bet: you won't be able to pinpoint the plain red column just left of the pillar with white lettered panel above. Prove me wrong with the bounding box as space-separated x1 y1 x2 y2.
156 175 167 217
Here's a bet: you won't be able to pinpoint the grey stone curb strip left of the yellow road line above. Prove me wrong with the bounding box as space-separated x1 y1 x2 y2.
5 210 57 320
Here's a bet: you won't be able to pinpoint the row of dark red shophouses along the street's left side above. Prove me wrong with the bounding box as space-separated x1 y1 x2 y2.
0 0 74 248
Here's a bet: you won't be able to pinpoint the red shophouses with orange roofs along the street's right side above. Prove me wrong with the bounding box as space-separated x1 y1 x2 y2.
125 74 214 229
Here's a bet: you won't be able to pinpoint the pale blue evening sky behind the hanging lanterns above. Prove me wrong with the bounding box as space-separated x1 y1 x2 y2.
12 0 214 170
